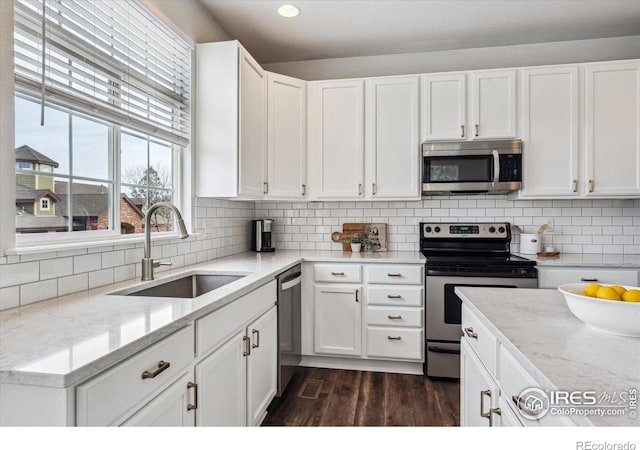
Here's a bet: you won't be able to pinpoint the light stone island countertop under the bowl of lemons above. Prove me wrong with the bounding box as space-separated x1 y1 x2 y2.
456 287 640 426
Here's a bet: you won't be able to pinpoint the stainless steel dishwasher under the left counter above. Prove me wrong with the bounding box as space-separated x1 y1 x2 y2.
277 264 302 397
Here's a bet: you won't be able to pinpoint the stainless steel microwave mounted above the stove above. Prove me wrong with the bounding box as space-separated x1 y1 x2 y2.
422 139 522 195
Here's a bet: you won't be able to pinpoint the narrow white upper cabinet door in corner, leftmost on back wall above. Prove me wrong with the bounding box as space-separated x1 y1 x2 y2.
267 72 307 199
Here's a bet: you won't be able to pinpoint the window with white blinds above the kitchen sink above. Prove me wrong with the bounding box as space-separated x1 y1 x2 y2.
14 0 191 243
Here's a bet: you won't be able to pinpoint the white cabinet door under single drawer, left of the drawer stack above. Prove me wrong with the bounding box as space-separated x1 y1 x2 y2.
314 284 362 356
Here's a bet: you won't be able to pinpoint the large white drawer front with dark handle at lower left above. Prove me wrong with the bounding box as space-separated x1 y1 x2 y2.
77 325 194 426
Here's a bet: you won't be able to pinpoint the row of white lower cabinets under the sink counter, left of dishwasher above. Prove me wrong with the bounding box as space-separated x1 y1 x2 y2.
75 281 278 426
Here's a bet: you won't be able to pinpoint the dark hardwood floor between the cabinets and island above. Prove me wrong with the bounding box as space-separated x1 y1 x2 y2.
263 367 460 426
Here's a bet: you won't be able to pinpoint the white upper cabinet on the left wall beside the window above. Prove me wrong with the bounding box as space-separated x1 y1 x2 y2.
195 41 266 199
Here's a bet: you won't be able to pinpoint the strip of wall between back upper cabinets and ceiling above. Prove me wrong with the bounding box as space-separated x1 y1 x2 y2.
263 36 640 80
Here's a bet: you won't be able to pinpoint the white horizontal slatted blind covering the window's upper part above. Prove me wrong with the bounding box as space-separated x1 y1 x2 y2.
15 0 191 146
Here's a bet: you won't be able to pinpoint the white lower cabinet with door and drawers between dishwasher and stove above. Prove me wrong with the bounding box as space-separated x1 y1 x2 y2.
302 263 424 374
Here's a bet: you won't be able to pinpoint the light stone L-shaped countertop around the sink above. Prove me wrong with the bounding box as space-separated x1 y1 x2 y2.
0 250 425 388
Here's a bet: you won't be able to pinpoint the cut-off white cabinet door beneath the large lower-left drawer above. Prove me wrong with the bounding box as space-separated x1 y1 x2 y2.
122 373 195 427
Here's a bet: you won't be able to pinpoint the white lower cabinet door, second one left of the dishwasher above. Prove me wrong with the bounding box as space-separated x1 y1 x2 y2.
195 329 247 426
